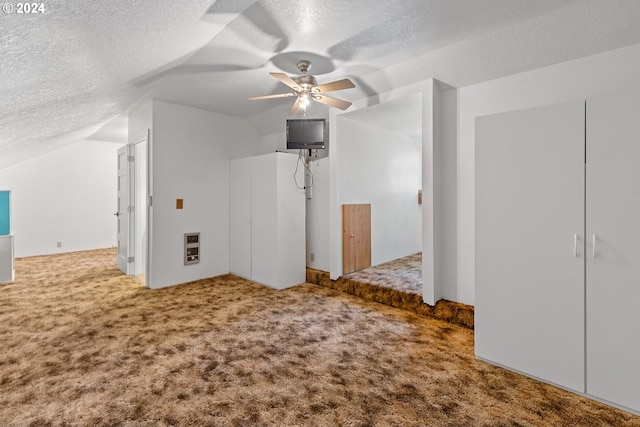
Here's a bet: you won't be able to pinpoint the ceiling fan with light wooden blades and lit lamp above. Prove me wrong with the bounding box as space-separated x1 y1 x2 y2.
249 60 356 115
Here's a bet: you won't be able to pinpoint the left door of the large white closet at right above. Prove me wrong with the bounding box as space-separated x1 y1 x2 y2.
475 102 584 392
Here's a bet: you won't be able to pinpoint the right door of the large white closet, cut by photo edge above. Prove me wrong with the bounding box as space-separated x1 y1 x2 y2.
586 92 640 411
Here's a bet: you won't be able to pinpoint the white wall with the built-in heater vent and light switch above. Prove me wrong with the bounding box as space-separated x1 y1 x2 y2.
149 101 262 288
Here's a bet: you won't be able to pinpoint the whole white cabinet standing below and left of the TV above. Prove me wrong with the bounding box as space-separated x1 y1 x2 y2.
229 153 306 289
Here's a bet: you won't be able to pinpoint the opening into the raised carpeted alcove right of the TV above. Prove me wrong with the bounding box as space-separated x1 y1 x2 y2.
337 93 423 295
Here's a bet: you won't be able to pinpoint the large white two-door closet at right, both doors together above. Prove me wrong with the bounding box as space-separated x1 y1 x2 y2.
475 92 640 412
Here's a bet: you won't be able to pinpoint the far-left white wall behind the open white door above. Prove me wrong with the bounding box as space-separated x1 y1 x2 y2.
0 141 122 263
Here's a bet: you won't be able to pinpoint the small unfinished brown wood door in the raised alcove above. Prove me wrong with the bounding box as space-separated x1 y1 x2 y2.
342 204 371 274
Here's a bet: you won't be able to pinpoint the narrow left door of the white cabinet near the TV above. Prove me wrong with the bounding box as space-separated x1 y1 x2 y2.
229 159 251 279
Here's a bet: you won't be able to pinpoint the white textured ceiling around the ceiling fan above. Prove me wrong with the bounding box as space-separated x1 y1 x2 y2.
0 0 640 166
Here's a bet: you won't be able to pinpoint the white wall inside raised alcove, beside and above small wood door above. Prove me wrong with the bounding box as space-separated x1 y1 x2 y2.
338 115 422 265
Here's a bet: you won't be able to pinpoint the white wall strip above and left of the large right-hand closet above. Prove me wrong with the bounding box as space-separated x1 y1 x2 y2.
452 44 640 304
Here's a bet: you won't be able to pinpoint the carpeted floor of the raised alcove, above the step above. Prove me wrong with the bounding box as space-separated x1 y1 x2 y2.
345 252 422 296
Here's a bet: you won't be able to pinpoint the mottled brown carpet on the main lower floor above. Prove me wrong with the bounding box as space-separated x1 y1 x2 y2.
0 249 640 426
